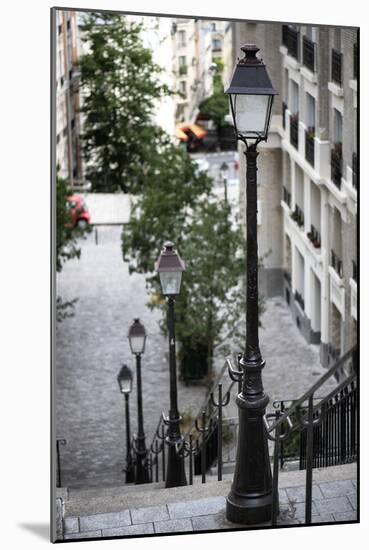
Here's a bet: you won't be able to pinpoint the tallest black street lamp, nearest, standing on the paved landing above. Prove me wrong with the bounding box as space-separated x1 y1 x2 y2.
225 44 277 524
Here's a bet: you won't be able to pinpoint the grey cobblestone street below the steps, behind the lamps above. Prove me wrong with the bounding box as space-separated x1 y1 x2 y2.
56 226 334 487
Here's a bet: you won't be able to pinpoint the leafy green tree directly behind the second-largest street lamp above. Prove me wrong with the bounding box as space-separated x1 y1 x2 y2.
122 150 245 384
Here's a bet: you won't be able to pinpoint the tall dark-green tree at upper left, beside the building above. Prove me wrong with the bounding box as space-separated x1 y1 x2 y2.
80 13 169 193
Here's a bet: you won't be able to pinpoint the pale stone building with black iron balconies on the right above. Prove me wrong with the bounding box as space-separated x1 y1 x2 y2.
233 22 358 366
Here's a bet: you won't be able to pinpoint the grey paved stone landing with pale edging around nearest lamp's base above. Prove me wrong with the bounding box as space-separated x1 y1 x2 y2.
57 464 357 540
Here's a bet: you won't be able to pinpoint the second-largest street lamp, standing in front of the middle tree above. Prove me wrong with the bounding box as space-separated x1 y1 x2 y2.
156 241 187 487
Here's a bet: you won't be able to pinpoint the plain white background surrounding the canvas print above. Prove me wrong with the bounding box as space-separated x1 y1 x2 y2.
0 0 369 550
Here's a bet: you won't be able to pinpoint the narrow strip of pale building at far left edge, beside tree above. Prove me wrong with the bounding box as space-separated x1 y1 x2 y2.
56 10 83 187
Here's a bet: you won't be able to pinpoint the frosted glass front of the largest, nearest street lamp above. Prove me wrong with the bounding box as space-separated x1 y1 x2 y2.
233 94 269 135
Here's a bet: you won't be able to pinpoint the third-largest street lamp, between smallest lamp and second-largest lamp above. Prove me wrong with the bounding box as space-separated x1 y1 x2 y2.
128 319 150 484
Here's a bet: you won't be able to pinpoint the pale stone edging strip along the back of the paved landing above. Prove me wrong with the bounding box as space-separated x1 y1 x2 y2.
64 463 357 517
